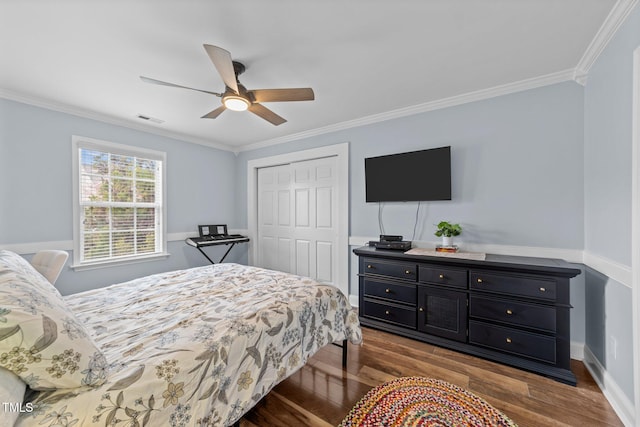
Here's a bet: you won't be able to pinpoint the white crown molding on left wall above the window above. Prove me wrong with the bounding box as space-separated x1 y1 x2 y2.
0 88 237 152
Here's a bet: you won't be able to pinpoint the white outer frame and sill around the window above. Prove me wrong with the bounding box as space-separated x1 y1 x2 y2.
71 135 169 270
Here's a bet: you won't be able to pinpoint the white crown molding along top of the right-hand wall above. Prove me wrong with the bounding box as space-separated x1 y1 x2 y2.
576 0 638 77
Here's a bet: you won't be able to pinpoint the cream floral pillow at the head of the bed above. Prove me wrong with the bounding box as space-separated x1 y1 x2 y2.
0 251 107 390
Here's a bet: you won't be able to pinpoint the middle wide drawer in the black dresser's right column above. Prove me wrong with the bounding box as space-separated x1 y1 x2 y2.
469 295 556 332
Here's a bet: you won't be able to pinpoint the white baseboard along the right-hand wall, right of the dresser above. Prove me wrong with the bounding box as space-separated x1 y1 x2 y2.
584 346 636 427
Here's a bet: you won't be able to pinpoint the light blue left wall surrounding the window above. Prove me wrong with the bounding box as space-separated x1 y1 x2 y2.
0 99 246 294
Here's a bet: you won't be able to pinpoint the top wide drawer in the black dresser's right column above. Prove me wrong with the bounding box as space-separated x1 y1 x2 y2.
469 270 556 301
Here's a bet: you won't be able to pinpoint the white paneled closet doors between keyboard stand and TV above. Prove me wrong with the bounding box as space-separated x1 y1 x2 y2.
258 157 338 284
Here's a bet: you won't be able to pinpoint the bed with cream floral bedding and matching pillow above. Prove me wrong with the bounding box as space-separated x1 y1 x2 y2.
0 251 362 426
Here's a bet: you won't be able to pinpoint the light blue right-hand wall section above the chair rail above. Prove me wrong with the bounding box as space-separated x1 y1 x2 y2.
584 7 640 265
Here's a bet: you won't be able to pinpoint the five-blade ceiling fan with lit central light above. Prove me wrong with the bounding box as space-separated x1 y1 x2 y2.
140 44 314 126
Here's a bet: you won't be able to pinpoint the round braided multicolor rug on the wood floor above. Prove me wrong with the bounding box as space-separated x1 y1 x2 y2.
340 377 516 427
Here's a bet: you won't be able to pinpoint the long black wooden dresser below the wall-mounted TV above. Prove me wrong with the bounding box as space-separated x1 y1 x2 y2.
353 246 581 385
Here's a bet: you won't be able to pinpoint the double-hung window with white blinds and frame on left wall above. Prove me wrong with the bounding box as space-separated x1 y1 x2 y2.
73 136 166 268
